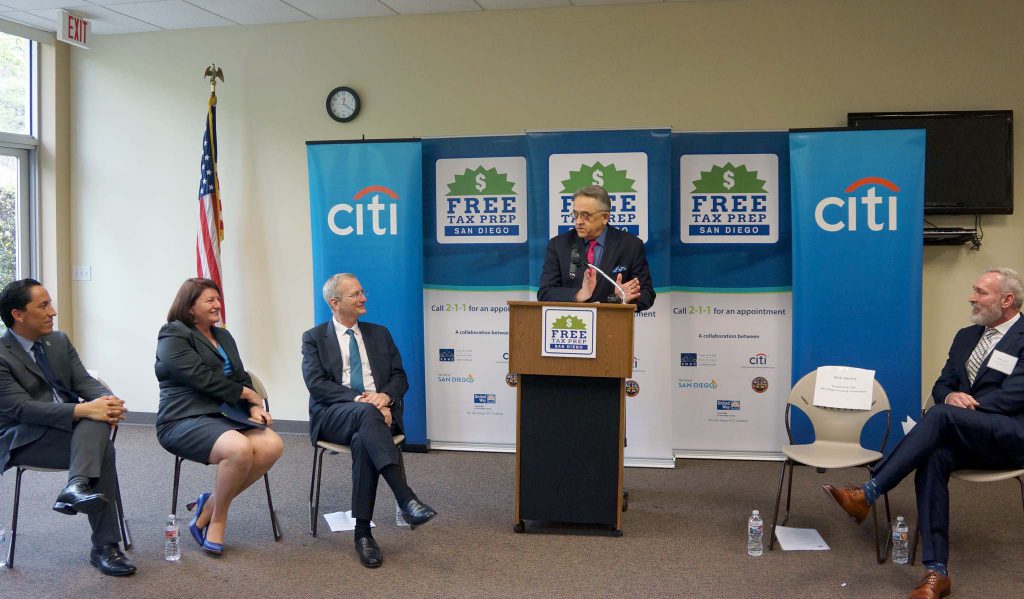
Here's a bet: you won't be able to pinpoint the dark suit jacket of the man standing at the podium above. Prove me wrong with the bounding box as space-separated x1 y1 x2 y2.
537 226 655 312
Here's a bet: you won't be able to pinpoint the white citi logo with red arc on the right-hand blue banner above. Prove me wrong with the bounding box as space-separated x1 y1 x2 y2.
814 177 900 232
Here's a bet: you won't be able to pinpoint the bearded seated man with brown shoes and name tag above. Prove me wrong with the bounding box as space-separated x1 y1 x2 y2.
824 268 1024 599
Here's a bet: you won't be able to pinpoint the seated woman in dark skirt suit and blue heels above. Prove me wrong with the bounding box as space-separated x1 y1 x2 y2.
156 279 284 555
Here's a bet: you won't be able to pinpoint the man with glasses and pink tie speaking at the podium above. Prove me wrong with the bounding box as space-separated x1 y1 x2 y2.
537 185 655 312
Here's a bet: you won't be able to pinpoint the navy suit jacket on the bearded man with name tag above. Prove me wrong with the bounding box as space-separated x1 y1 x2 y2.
932 315 1024 446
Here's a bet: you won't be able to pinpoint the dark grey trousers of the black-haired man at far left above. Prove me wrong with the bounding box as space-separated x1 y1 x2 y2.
10 420 121 547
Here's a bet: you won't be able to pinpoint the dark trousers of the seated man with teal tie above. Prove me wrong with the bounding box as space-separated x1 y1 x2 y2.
319 401 401 520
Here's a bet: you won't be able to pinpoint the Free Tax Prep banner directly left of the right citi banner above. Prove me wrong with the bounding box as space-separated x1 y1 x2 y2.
671 131 792 457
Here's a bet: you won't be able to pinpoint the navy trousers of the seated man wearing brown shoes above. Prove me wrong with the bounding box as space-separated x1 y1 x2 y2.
873 403 1024 563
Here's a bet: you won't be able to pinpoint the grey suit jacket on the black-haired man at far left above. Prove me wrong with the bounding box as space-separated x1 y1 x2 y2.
0 331 111 469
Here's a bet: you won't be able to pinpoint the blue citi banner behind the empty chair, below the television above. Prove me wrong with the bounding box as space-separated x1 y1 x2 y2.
790 129 925 453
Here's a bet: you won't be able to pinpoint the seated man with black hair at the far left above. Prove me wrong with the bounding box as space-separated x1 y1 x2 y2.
0 279 135 576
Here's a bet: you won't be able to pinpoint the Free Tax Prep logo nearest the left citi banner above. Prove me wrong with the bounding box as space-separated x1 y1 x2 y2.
434 157 526 244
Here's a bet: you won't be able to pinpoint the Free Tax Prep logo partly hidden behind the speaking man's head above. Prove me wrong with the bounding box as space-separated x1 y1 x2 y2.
548 152 648 242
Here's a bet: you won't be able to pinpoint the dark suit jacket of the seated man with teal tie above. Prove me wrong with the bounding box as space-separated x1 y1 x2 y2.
302 318 409 443
